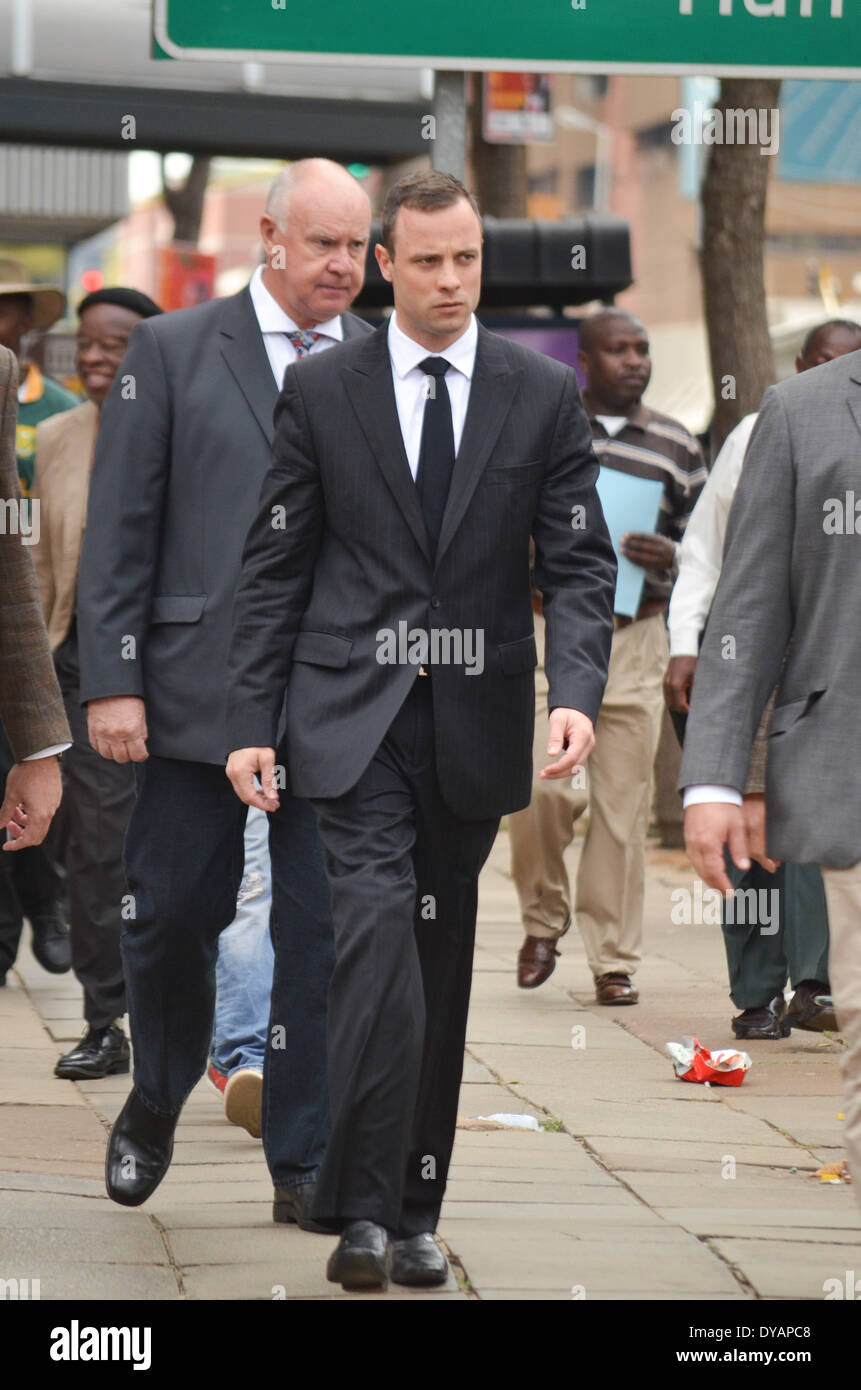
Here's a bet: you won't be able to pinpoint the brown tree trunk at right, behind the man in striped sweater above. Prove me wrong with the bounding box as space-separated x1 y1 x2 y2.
701 78 780 455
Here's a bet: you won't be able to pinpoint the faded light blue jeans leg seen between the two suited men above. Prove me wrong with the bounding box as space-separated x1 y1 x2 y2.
210 806 275 1076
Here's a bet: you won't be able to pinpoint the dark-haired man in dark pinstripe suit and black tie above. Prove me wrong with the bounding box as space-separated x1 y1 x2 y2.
228 174 616 1289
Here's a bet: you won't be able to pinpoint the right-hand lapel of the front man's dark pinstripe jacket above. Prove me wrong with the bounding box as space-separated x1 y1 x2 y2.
437 327 522 564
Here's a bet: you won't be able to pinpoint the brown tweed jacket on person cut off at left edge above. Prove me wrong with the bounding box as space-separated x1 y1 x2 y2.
0 348 72 762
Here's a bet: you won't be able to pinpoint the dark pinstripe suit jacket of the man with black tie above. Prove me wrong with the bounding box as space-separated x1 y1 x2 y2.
228 327 616 820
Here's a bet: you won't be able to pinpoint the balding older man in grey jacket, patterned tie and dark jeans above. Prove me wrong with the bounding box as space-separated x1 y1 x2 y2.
78 160 370 1223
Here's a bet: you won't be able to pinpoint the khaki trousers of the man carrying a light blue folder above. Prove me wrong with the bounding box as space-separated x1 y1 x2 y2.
509 613 669 977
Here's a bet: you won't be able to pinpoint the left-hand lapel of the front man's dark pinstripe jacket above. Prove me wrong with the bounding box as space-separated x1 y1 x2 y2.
344 324 431 560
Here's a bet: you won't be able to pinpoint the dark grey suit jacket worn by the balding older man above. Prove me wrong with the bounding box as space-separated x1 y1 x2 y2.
78 280 370 763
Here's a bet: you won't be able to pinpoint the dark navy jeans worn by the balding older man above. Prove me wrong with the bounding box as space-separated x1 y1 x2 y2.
122 753 334 1186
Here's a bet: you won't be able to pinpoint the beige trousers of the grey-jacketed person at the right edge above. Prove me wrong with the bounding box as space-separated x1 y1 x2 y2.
822 863 861 1205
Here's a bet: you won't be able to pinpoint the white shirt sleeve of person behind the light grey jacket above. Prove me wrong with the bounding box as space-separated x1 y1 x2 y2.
666 411 758 656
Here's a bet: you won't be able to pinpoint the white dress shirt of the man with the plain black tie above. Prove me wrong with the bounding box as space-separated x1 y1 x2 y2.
388 314 478 478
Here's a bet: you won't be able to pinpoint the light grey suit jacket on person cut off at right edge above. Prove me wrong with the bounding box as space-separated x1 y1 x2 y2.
680 352 861 869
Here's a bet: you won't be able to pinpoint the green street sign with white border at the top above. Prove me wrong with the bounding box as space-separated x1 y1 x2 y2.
154 0 861 78
